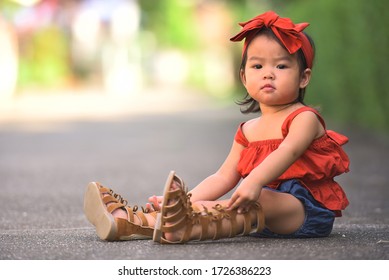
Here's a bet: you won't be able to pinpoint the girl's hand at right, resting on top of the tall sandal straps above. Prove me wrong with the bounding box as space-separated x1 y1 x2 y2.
227 181 261 213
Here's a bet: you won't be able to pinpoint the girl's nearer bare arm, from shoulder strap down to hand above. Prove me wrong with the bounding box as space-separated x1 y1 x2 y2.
228 112 324 210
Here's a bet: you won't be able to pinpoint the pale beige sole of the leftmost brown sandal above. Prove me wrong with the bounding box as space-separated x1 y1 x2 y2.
84 182 118 241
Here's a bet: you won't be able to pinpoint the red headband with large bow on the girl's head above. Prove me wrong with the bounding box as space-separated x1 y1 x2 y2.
230 11 314 68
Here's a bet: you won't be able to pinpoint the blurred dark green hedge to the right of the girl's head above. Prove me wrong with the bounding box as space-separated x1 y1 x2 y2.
280 0 389 130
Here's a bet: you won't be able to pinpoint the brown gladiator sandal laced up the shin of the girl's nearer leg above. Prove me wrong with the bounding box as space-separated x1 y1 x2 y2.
153 171 265 243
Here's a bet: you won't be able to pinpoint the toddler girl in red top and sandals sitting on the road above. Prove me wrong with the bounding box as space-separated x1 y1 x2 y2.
84 11 349 243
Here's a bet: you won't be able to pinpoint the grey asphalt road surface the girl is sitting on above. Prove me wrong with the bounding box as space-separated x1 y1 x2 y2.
0 92 389 260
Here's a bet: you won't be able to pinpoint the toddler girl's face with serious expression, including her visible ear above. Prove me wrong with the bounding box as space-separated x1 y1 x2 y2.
240 34 311 107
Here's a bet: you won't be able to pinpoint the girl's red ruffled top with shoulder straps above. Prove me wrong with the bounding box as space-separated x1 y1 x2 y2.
235 107 350 216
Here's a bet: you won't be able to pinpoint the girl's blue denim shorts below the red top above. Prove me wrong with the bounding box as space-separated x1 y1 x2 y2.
252 180 335 238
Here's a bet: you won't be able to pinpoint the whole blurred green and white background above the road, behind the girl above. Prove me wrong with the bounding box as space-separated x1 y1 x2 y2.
0 0 389 132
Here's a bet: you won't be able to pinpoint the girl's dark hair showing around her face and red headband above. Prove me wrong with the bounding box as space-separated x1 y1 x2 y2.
236 28 315 114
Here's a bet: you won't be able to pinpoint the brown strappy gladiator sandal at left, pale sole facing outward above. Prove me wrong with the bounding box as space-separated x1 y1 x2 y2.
84 182 157 241
